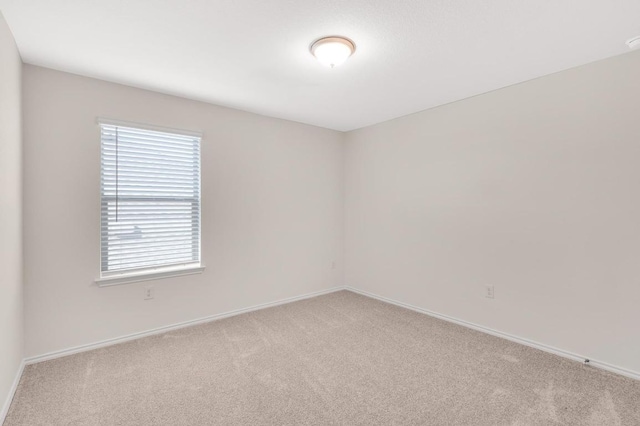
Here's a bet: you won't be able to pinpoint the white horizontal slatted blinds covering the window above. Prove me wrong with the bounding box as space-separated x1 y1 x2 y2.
100 123 200 276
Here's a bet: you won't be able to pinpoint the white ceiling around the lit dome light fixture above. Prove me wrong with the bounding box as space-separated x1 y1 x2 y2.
0 0 640 131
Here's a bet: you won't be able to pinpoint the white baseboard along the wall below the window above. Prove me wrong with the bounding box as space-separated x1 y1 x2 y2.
26 287 345 364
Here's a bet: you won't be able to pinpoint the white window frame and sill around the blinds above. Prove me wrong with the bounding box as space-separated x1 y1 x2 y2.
95 117 205 287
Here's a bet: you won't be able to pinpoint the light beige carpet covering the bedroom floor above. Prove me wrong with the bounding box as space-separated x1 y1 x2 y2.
5 291 640 426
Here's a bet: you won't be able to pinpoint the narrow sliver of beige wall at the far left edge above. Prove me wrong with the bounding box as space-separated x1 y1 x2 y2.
0 10 23 422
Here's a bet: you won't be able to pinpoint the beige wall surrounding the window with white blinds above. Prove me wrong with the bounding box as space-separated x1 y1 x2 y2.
23 65 343 356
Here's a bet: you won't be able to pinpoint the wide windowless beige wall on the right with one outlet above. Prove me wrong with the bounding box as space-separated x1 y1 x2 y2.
345 52 640 372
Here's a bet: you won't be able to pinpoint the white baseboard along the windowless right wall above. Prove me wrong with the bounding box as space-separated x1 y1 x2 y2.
345 286 640 380
